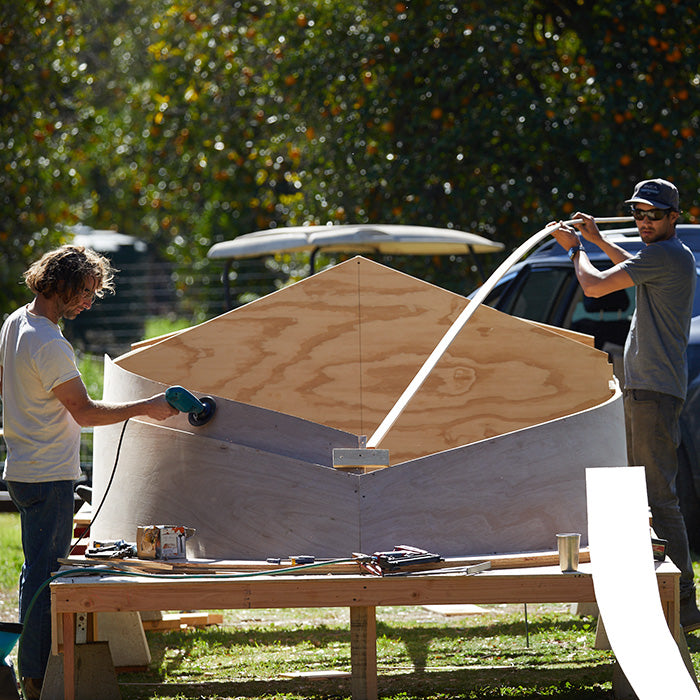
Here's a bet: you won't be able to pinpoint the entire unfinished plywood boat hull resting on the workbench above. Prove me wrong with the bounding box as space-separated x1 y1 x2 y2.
92 258 626 559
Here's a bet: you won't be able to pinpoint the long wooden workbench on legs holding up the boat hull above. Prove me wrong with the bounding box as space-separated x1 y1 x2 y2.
51 563 680 700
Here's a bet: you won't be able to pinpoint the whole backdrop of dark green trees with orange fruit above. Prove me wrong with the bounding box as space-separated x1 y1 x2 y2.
0 0 700 313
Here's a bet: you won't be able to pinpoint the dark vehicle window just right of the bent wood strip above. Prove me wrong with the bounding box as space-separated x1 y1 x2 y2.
500 267 573 323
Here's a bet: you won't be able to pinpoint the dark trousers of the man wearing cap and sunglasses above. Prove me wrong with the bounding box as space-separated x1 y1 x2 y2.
623 389 695 599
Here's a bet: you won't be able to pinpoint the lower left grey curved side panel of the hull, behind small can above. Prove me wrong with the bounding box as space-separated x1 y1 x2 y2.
91 420 360 559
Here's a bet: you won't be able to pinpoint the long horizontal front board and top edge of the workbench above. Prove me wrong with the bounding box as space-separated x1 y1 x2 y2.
52 564 604 613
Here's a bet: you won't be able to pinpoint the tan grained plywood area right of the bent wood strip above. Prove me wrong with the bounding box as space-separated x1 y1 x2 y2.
381 318 612 463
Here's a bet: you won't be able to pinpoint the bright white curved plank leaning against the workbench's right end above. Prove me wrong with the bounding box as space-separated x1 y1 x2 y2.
586 467 700 700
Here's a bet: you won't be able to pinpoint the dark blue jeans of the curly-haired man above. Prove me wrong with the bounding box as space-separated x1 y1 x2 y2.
7 481 74 678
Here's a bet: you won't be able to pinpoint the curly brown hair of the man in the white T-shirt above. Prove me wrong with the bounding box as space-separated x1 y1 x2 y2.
24 245 117 302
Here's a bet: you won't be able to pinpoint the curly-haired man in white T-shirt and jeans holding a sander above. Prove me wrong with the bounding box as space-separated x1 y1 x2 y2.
0 245 177 700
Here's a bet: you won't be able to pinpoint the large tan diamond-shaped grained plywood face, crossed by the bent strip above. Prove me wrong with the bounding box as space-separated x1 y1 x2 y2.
110 258 612 463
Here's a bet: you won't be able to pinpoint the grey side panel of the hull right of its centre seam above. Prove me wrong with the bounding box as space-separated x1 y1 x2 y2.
360 393 626 556
